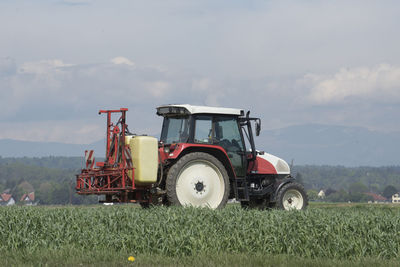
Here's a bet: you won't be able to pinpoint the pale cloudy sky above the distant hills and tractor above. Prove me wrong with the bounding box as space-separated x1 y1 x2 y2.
0 0 400 143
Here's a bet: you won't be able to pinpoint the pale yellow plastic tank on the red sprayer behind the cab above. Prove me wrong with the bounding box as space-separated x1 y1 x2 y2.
125 136 158 184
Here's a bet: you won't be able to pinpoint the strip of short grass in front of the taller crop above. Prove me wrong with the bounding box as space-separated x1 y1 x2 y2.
0 249 399 267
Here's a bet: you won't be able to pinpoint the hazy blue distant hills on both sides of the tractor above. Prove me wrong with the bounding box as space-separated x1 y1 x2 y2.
0 124 400 166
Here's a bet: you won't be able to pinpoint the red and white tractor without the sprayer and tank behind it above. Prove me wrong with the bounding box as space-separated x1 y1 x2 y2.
157 105 307 209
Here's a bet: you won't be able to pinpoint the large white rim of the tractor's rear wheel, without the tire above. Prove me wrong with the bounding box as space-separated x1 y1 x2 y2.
176 160 225 209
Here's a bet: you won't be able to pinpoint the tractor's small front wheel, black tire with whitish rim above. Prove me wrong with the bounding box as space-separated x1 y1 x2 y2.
276 182 308 210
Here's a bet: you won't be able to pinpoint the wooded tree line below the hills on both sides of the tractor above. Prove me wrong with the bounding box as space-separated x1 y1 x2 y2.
0 157 400 204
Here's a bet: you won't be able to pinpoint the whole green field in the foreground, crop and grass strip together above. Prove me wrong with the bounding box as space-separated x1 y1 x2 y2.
0 204 400 266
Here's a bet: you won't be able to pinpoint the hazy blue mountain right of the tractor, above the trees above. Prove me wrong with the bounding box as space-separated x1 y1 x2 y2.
256 124 400 166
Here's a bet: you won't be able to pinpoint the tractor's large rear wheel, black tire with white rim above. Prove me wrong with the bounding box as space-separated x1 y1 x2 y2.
166 152 230 209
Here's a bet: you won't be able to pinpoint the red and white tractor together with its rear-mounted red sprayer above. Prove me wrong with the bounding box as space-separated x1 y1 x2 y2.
76 104 308 210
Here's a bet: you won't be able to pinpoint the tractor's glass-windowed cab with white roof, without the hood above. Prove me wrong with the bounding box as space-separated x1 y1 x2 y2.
157 105 248 177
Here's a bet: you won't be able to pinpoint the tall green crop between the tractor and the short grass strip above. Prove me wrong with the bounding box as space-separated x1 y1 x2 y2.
0 205 400 259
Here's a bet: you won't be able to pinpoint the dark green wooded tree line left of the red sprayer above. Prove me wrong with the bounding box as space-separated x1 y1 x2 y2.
0 157 97 205
